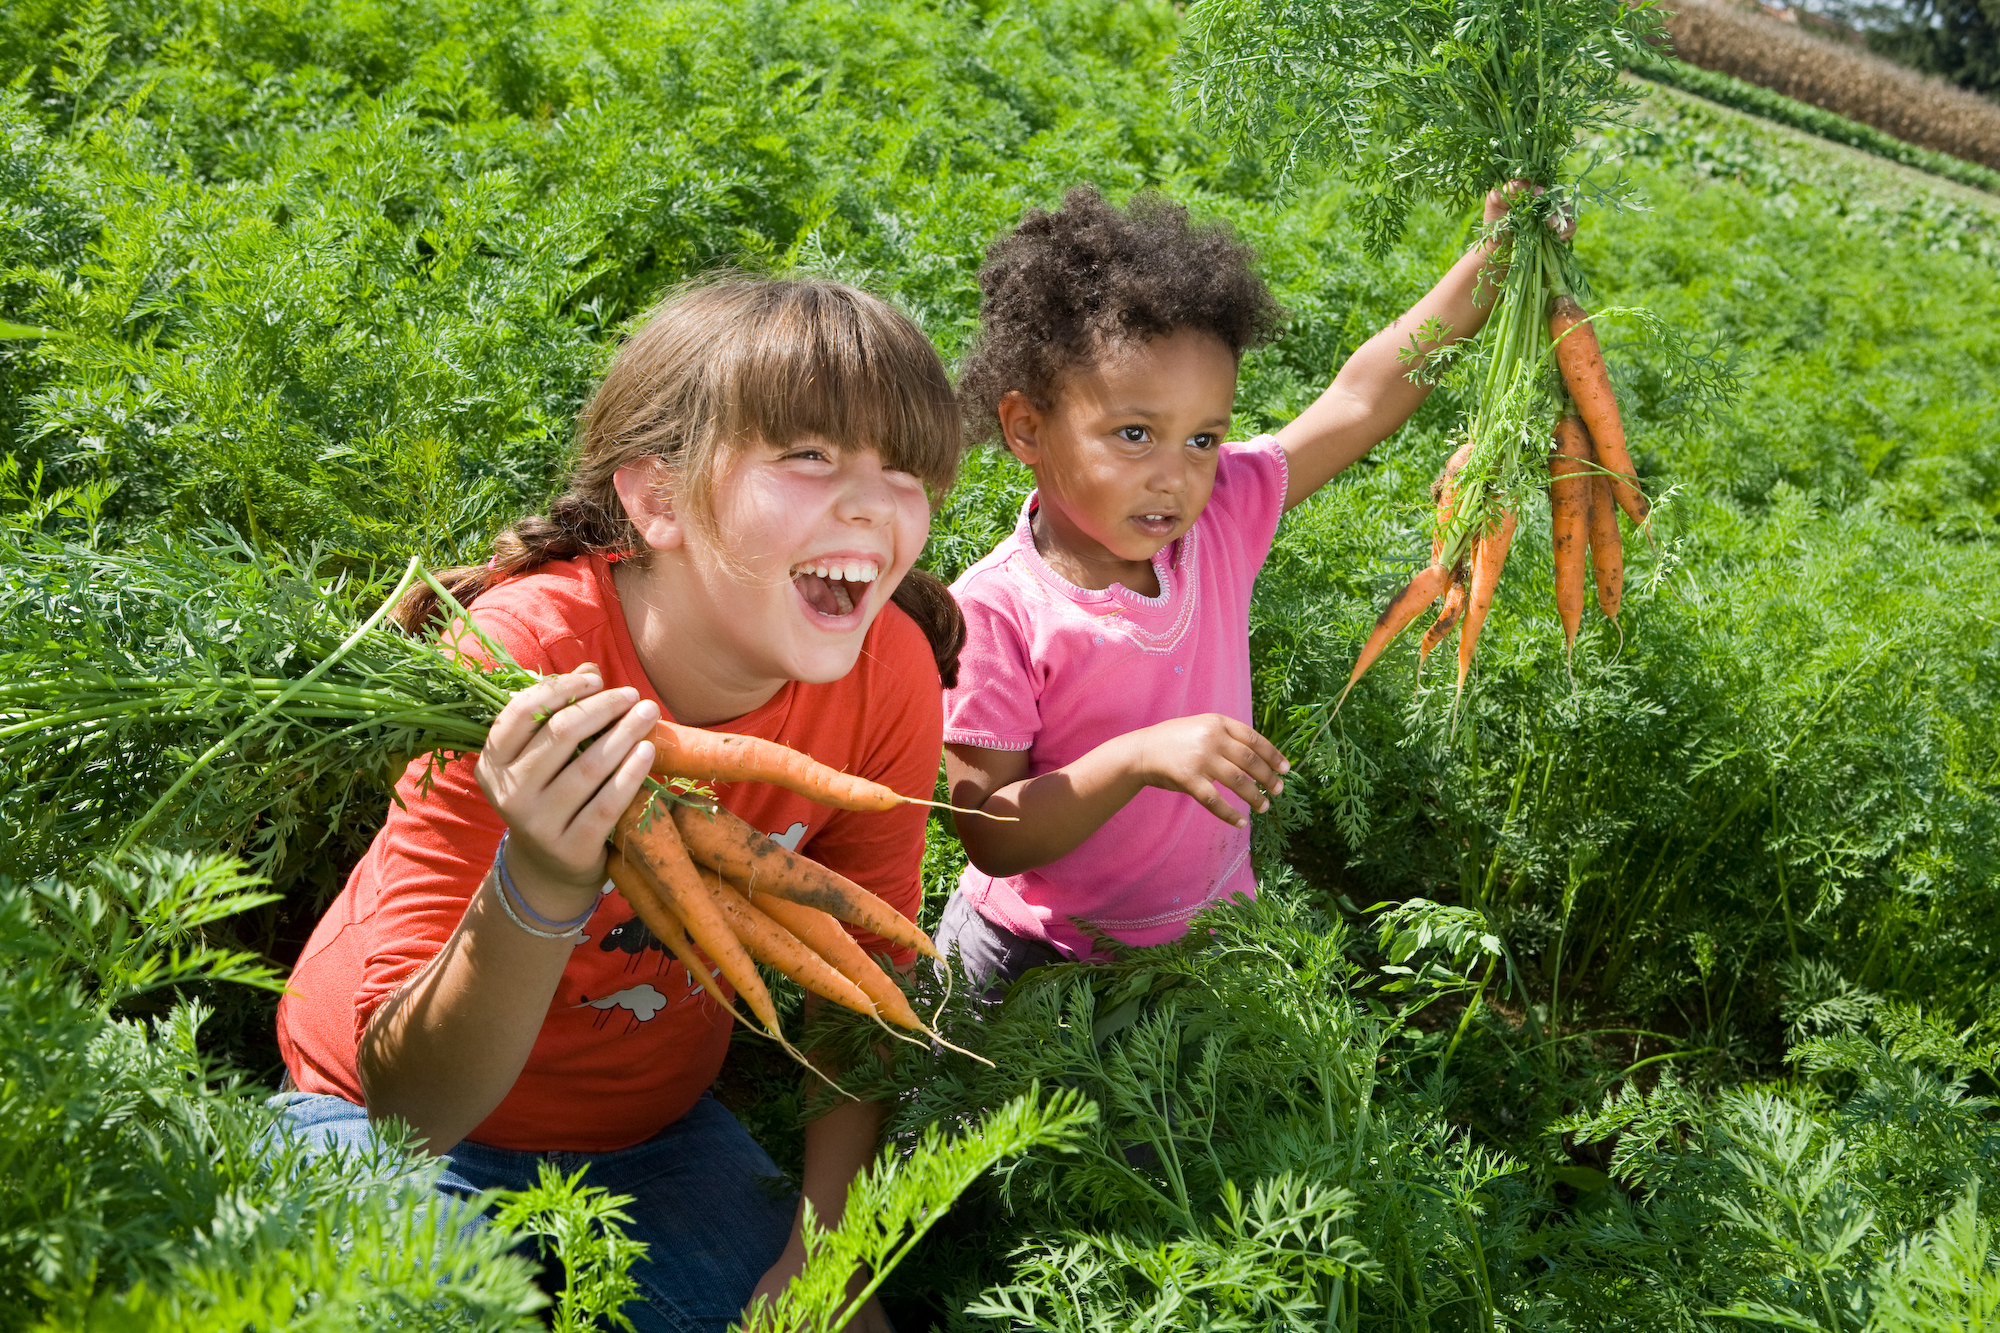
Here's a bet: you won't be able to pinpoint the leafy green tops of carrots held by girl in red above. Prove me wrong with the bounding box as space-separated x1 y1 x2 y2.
0 508 528 892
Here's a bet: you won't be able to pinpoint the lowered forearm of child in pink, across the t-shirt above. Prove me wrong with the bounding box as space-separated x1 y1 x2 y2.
956 737 1146 875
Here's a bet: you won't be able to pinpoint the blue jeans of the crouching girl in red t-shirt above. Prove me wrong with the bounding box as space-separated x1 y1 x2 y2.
284 1093 798 1333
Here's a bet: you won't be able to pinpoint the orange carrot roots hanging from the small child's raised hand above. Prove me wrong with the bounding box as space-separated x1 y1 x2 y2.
1340 294 1650 701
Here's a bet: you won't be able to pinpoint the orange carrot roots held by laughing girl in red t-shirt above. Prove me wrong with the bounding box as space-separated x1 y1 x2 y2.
610 723 960 1041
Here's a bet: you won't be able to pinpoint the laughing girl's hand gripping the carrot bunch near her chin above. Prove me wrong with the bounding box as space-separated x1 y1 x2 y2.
476 664 660 921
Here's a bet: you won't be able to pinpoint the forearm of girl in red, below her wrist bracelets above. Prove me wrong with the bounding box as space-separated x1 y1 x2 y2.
358 873 576 1155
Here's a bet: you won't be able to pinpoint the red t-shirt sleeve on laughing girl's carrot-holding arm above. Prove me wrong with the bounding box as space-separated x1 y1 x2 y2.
352 610 548 1041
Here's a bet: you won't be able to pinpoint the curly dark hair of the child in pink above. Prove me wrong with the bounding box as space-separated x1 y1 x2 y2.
958 186 1284 440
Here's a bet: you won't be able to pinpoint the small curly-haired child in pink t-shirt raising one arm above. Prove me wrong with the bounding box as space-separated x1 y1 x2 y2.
938 182 1560 985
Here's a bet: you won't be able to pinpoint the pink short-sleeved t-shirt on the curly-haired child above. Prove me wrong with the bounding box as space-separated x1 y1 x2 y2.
944 434 1286 957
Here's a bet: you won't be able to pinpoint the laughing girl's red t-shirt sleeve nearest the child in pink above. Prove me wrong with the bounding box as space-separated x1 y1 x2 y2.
800 612 942 967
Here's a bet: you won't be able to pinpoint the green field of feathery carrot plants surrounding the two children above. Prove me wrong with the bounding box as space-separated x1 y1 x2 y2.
0 0 2000 1333
